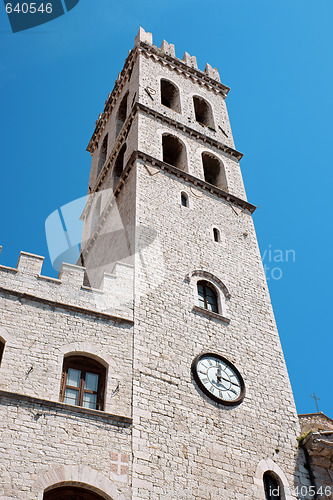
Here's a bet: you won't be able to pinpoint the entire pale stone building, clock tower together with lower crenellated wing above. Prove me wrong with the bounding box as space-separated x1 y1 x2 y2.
0 28 325 500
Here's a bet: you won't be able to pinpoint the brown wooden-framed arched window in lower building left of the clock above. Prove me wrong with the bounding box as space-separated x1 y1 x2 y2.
60 356 106 410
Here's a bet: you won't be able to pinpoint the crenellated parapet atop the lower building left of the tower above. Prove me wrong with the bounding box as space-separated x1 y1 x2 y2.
0 248 133 321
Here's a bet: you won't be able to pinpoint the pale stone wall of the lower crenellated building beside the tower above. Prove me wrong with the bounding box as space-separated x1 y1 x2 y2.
0 253 133 500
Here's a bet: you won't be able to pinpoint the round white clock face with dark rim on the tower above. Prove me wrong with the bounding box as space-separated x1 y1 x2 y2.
192 353 245 406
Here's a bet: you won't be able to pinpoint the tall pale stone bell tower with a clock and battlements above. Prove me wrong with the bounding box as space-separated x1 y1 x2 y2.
81 28 309 500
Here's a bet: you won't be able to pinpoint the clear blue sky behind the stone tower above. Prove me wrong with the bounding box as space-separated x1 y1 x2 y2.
0 0 333 418
